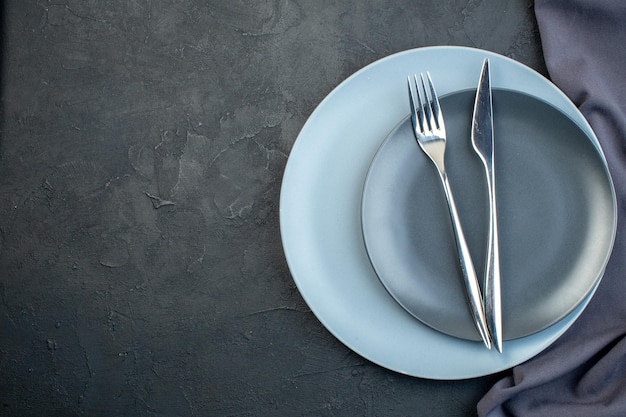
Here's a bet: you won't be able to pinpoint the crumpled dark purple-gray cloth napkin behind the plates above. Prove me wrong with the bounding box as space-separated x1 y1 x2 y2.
478 0 626 417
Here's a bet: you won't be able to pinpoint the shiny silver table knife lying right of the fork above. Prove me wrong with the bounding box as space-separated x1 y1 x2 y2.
472 58 502 353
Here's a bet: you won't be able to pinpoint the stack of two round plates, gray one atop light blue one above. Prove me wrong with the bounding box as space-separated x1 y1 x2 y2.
280 47 617 379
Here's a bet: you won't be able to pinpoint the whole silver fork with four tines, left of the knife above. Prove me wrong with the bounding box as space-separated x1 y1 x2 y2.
408 72 491 349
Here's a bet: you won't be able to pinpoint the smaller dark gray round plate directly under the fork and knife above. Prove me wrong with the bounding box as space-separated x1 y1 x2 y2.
362 90 616 340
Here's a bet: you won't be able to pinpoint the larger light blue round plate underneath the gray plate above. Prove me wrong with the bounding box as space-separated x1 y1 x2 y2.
280 47 616 379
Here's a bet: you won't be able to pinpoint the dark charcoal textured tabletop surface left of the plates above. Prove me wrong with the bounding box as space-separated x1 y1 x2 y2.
0 0 545 417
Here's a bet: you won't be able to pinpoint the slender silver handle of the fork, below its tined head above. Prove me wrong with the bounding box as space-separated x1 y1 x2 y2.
439 170 491 349
